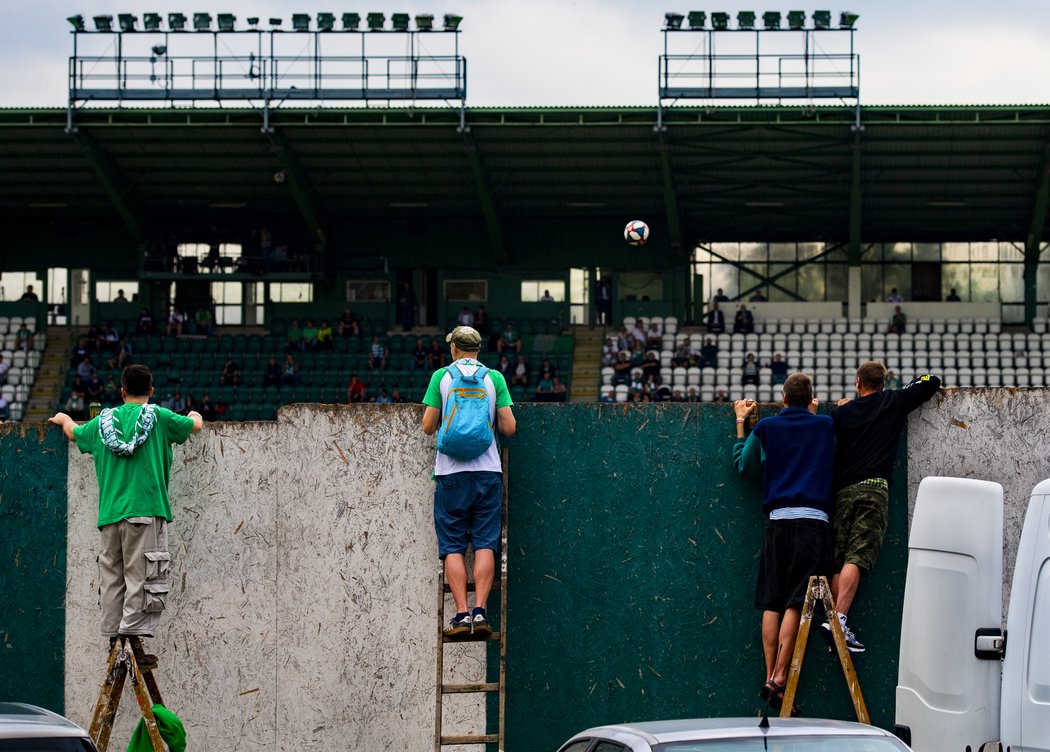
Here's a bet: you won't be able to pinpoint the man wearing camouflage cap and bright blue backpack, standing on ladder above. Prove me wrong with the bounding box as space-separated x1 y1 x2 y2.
423 327 518 640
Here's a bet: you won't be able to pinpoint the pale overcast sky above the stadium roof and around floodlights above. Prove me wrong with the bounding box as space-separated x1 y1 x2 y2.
0 0 1050 107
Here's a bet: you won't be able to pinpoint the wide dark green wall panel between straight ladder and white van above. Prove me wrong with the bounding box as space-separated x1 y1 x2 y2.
506 403 907 752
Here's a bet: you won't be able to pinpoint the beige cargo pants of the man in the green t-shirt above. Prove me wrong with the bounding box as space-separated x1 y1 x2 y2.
99 517 171 638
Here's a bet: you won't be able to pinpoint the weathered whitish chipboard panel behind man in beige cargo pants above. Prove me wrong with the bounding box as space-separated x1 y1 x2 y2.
66 423 277 751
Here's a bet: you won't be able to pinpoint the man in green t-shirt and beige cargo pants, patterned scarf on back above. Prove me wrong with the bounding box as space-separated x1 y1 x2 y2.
48 365 204 640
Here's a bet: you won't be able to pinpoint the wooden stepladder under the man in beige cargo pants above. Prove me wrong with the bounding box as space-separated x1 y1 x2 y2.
88 636 168 752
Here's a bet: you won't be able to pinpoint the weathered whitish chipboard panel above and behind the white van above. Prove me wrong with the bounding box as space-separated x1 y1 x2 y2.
908 389 1050 620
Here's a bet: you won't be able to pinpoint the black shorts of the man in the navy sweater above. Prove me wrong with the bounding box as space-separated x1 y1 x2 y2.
755 520 832 611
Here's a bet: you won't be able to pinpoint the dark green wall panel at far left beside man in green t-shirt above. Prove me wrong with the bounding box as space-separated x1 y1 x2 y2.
0 423 67 713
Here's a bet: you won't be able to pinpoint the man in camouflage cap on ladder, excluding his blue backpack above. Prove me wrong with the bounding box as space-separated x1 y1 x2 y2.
423 327 518 640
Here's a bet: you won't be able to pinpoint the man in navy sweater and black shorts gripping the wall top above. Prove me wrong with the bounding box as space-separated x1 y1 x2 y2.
733 373 835 712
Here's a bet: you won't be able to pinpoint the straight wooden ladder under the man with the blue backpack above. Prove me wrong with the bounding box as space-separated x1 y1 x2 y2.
434 450 509 752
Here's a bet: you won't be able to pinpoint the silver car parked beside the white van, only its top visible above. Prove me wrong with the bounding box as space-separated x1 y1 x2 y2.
559 717 910 752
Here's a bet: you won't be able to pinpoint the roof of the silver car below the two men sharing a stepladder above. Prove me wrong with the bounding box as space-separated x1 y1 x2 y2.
573 717 891 745
